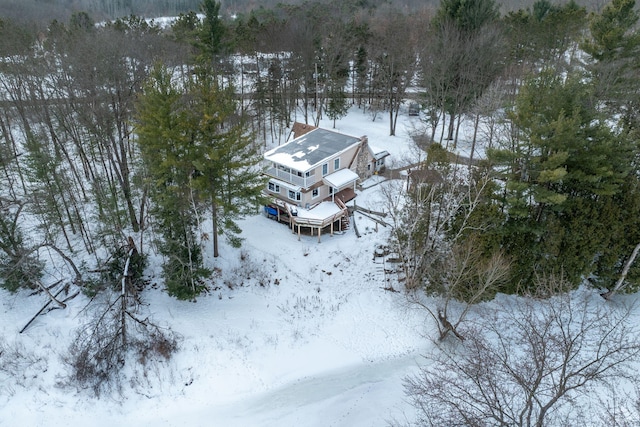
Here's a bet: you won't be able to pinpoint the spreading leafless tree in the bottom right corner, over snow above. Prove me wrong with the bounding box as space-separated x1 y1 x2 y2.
405 278 640 427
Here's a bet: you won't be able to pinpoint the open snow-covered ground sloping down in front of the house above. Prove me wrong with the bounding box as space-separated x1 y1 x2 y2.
0 109 434 427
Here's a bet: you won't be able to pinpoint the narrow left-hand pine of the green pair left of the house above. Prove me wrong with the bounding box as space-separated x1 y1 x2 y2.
136 67 208 299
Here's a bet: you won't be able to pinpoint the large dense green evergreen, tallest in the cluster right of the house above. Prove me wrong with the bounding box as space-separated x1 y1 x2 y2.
489 70 633 285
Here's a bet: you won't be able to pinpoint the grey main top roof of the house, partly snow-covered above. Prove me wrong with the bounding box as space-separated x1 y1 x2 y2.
264 128 361 172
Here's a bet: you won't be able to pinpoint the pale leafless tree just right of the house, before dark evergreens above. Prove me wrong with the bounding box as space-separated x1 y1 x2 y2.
383 155 496 293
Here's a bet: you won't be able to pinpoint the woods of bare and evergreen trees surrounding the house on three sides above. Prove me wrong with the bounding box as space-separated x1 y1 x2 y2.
0 0 640 298
